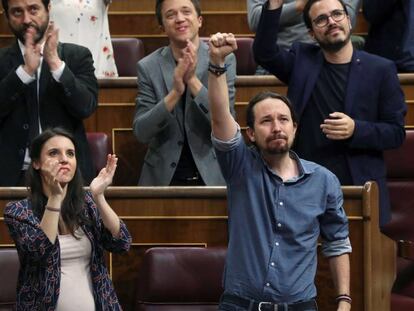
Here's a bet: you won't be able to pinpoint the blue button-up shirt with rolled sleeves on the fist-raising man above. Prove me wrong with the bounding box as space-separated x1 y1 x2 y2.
212 130 351 303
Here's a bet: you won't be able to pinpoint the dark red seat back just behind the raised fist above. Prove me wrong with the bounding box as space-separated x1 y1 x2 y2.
200 37 257 76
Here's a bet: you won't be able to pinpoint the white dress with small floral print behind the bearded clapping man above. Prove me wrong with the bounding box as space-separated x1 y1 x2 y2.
50 0 118 78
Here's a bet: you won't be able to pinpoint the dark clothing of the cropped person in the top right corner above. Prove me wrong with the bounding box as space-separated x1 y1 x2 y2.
362 0 414 72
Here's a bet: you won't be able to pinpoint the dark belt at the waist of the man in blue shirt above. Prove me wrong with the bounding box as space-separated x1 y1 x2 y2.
221 294 317 311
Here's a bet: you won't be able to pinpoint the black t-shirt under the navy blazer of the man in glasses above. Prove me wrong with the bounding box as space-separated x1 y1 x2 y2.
293 62 353 185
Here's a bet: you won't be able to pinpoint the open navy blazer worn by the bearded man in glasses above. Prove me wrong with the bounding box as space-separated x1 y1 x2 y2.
253 4 407 224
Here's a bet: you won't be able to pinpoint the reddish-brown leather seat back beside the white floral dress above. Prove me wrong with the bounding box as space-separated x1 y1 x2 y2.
111 38 145 77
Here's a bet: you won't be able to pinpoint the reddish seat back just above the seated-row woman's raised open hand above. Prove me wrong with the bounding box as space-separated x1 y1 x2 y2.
86 132 111 175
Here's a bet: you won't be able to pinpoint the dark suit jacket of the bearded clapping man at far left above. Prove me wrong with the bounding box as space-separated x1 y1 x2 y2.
0 42 98 186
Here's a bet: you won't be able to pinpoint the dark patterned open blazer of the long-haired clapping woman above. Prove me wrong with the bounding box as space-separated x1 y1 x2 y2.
4 192 131 311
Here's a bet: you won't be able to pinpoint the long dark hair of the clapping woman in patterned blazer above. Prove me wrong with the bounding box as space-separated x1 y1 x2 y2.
27 127 89 238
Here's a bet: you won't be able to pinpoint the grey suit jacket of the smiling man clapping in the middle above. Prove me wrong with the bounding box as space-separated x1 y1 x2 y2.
133 41 236 186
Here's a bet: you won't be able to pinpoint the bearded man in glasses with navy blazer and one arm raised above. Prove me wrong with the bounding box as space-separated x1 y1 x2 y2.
254 0 406 225
